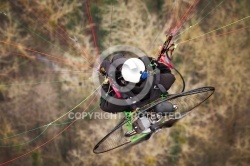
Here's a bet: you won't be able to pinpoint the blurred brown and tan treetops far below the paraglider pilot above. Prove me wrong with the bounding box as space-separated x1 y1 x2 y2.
0 0 250 166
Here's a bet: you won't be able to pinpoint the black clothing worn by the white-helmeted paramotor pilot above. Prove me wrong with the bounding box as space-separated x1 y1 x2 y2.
100 55 175 113
